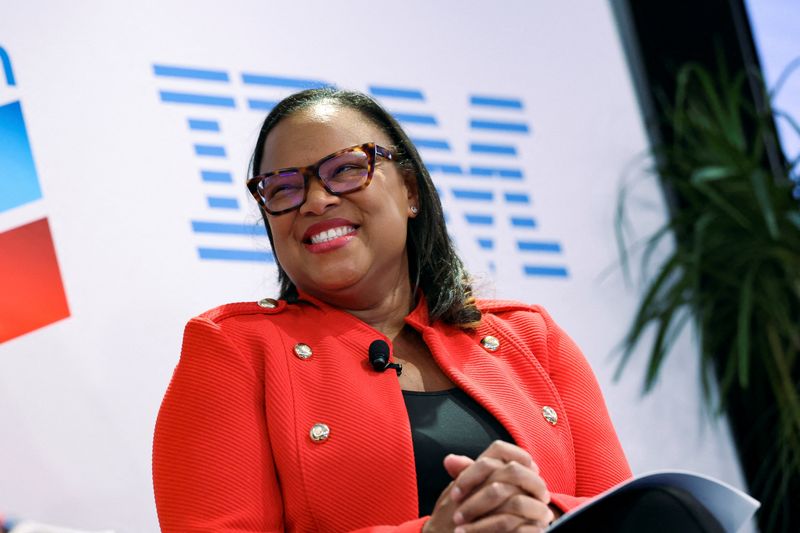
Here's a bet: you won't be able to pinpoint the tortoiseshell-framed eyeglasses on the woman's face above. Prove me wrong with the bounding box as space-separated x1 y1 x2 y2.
247 143 394 215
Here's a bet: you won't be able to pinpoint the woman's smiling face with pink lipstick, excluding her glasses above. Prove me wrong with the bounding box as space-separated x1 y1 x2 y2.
260 102 418 309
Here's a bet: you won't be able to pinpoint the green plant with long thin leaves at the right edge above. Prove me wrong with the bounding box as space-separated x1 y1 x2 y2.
616 64 800 531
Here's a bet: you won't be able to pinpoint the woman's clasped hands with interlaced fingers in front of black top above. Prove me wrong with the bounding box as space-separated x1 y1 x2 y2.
422 441 555 533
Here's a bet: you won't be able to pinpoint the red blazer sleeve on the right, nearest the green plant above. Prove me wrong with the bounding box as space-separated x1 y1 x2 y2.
538 308 631 511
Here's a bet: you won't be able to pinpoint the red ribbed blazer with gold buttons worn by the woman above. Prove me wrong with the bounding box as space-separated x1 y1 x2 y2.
153 298 631 533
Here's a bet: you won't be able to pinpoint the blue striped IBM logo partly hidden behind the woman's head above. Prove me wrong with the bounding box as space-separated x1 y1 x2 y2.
153 64 569 278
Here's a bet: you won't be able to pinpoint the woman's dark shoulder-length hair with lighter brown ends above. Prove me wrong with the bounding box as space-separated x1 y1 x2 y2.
250 87 481 328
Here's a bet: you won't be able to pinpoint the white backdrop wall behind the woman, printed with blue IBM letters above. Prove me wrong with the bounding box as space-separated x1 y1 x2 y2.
0 0 742 532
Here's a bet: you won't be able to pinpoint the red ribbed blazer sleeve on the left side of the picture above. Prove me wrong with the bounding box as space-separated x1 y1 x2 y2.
153 317 428 533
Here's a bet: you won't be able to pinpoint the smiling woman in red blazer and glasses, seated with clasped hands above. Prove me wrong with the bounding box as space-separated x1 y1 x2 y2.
153 89 630 533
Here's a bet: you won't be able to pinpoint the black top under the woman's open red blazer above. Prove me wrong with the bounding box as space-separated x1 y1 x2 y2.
403 389 514 516
